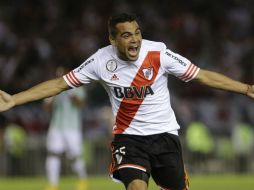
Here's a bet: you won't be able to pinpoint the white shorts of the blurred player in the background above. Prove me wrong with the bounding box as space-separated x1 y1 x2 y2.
47 128 82 158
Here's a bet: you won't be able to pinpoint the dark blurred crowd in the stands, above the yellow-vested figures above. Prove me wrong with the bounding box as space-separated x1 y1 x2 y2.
0 0 254 175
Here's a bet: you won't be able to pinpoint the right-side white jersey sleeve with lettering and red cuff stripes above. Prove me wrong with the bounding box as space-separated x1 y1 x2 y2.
160 49 200 82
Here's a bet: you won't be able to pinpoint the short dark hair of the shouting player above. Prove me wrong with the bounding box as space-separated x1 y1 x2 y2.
108 13 138 37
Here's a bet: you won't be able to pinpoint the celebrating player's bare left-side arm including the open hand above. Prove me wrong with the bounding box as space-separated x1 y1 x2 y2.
0 77 69 112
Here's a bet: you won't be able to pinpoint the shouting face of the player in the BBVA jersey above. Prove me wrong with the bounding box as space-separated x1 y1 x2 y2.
110 21 142 61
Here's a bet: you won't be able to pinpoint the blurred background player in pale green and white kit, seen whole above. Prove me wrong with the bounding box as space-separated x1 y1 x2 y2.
45 67 87 190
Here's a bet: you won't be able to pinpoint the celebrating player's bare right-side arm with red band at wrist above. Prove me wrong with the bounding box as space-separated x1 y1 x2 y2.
195 69 254 98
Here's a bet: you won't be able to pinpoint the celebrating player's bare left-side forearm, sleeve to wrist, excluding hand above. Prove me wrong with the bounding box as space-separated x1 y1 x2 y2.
12 77 69 106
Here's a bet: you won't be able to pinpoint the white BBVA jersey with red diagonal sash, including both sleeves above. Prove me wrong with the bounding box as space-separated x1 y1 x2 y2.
64 40 199 135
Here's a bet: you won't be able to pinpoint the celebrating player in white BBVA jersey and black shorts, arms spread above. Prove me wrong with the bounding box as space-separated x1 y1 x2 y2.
0 14 254 190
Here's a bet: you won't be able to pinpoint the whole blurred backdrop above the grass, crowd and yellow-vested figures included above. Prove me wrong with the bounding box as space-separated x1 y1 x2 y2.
0 0 254 180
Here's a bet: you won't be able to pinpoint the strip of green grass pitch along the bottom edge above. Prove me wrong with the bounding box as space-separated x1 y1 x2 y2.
0 175 254 190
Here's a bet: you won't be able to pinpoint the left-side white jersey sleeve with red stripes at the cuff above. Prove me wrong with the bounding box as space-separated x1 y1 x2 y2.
63 53 99 88
